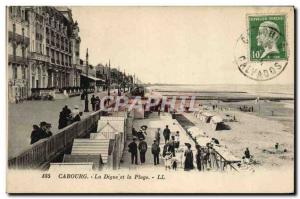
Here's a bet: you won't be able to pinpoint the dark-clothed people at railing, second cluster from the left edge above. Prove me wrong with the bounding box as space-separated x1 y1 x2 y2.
58 105 82 129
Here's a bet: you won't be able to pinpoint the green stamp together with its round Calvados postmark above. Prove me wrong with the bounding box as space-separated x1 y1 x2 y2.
235 14 288 81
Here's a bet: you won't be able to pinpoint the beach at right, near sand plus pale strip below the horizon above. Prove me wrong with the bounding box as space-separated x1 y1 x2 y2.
150 86 294 169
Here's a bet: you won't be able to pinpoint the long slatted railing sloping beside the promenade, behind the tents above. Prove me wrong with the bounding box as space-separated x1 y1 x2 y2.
8 111 100 169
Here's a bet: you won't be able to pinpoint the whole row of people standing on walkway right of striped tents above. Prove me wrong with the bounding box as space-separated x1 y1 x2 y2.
128 126 224 171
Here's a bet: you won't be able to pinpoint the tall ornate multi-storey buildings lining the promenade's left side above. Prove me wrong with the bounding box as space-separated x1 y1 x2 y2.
8 6 81 102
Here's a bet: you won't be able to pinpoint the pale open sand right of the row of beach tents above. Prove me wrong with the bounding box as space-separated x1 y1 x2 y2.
184 104 294 168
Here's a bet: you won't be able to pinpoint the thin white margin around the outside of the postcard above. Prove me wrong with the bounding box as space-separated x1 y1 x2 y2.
0 0 300 198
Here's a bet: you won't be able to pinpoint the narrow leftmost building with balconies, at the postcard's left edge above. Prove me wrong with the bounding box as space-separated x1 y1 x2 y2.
7 6 30 102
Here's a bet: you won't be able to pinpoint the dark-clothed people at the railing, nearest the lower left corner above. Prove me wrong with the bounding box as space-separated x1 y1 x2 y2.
30 122 52 144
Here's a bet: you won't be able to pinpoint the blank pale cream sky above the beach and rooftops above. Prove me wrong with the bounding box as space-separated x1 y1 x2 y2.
70 7 294 84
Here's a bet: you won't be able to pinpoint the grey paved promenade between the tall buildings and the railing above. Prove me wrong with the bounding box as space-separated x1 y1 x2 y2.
8 92 107 157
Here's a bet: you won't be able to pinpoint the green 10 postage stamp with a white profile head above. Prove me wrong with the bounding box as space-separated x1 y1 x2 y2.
248 15 287 61
